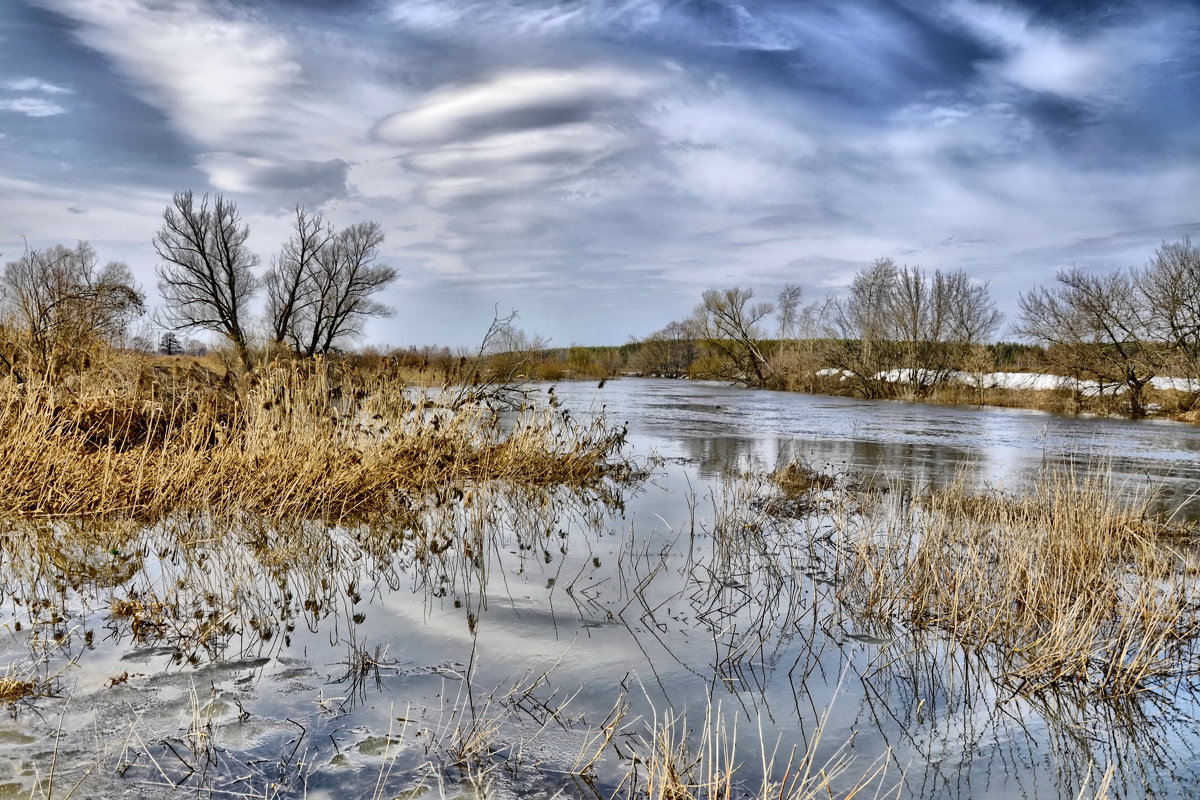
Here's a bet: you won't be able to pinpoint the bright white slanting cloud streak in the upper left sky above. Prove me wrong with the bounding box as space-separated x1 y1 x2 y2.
34 0 300 145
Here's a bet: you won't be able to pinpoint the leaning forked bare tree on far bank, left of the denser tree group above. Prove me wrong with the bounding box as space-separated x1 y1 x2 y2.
690 288 775 386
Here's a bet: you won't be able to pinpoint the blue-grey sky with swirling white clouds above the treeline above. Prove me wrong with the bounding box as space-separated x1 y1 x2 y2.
0 0 1200 347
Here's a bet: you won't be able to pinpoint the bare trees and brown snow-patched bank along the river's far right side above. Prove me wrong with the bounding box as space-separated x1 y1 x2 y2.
386 240 1200 416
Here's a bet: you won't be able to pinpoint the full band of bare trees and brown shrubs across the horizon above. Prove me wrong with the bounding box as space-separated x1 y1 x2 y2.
0 192 1200 421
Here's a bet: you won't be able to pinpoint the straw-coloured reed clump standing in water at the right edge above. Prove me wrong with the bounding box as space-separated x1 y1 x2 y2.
836 473 1200 697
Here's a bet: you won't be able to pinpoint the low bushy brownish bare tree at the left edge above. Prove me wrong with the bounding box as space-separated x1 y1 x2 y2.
0 242 145 378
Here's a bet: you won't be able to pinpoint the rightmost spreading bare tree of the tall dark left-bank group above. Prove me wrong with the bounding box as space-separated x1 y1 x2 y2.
289 222 400 355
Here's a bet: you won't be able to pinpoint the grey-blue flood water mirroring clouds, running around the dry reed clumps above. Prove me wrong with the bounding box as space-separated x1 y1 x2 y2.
0 379 1200 799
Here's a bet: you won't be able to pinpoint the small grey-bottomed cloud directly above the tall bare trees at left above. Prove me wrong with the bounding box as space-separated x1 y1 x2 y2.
200 152 350 207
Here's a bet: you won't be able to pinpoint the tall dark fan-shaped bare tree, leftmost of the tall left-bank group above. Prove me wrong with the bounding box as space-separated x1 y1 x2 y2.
154 192 259 369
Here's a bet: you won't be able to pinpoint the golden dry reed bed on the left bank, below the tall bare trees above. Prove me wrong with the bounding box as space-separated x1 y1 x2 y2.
0 362 624 521
